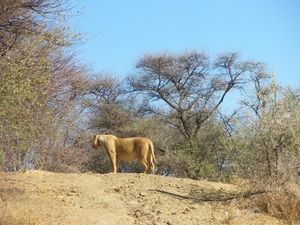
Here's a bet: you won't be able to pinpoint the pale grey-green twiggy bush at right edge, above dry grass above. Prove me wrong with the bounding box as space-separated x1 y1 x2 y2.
227 79 300 181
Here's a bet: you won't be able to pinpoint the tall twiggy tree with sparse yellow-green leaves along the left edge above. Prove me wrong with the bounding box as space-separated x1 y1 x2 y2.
0 0 87 171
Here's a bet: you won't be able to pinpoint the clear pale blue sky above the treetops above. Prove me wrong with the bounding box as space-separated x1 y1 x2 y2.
73 0 300 87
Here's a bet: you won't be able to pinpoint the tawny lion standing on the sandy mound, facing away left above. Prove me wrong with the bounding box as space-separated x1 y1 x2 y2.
93 134 157 174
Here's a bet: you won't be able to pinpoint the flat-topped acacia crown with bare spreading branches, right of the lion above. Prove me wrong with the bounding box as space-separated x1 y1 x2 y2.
127 50 264 140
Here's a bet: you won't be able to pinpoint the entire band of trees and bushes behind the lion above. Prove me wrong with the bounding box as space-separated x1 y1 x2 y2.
0 0 300 182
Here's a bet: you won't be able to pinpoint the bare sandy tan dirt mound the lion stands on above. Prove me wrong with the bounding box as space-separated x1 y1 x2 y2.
0 171 281 225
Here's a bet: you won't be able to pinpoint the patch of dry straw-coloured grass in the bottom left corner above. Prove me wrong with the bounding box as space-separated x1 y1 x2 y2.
0 180 69 225
